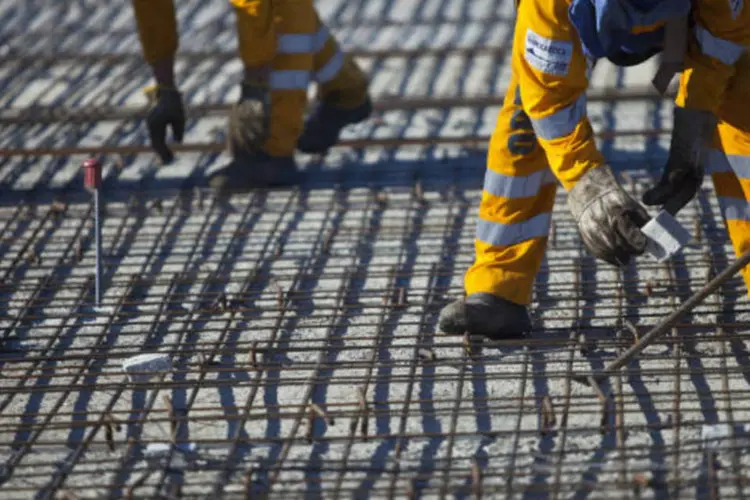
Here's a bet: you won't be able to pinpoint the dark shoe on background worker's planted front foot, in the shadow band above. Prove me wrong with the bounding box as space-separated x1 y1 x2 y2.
208 151 302 195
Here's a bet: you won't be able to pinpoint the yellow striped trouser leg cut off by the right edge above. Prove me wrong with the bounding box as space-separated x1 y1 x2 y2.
709 54 750 294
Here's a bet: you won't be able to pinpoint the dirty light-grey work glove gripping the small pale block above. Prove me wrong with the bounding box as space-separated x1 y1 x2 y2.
568 165 649 266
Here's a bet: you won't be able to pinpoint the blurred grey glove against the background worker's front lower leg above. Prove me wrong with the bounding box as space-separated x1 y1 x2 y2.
227 83 270 157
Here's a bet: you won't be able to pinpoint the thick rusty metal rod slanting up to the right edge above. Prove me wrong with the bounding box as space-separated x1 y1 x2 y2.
594 250 750 381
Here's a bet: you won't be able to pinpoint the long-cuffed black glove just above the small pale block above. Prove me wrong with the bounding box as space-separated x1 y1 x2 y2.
643 107 717 215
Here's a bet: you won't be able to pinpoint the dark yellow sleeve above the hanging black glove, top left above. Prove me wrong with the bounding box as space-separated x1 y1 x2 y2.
132 0 178 64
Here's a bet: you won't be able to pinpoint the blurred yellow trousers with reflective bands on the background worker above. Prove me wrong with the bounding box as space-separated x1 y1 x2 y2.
230 0 367 156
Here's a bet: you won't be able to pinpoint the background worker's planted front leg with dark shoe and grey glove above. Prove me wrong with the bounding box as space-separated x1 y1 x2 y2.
210 0 318 191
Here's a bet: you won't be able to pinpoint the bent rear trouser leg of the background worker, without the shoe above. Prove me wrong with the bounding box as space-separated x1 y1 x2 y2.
313 12 367 108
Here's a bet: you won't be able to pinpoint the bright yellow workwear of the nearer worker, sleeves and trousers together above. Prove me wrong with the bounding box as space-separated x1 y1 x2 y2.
465 0 750 305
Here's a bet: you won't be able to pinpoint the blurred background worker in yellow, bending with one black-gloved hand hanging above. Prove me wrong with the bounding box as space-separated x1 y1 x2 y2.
132 0 372 192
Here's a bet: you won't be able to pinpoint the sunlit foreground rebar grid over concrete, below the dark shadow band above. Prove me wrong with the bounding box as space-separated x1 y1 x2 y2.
0 175 750 498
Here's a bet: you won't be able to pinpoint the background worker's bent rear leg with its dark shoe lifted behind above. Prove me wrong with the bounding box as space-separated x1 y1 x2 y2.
298 12 372 154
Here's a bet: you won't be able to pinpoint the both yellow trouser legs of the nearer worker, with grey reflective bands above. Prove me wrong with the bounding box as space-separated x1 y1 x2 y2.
465 54 750 304
